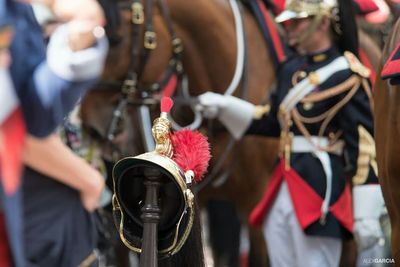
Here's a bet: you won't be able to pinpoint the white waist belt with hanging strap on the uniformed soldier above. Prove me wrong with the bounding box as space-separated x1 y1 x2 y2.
291 136 342 222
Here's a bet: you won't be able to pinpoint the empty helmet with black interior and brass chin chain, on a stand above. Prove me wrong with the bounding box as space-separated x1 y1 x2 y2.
112 152 194 258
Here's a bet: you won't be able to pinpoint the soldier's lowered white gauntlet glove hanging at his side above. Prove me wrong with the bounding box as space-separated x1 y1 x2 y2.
353 184 385 251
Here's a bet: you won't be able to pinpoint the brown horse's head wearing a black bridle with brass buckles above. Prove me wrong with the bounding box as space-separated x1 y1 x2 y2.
81 0 179 160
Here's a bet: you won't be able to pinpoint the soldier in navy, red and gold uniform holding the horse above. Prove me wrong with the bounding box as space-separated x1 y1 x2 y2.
199 0 384 266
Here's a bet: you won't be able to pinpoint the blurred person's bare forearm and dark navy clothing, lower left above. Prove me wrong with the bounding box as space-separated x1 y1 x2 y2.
23 134 105 267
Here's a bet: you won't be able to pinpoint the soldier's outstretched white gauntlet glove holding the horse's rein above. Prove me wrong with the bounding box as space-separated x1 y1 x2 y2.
198 92 255 139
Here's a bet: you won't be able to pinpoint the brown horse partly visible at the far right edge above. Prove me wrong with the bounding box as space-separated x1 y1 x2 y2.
374 19 400 263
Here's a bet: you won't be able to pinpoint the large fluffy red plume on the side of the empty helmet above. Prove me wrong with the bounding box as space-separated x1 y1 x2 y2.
171 129 211 183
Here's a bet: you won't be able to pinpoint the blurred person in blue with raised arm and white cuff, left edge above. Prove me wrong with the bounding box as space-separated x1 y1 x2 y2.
0 0 108 266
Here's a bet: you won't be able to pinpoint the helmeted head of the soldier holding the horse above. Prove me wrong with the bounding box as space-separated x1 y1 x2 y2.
276 0 358 54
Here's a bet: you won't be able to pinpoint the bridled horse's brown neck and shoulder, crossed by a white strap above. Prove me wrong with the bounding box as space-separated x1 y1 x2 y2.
165 0 275 100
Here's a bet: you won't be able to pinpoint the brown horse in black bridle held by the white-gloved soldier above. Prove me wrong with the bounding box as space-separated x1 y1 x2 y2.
82 0 277 266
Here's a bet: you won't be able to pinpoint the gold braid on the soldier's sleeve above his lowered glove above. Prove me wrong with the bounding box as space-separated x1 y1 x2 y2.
352 125 378 185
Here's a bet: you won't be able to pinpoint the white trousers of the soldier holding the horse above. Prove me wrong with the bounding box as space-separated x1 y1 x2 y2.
263 182 342 267
